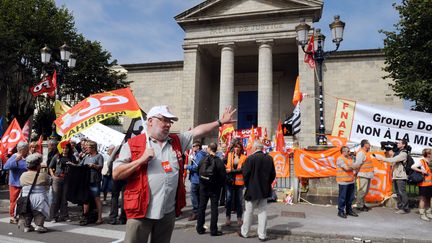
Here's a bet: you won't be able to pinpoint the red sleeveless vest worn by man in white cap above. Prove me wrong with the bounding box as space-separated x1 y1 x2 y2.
124 134 186 219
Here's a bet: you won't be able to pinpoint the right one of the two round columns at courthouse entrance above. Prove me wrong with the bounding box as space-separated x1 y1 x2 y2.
258 41 273 133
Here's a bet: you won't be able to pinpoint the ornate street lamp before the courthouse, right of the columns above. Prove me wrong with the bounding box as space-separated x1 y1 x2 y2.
295 15 345 145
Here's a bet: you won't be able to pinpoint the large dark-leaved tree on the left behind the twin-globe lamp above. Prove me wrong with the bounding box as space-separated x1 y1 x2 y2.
0 0 130 131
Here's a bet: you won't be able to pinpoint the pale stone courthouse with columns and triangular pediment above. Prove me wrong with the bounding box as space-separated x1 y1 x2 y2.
122 0 403 147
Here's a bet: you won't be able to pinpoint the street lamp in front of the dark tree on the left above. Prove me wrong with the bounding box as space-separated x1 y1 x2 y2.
41 43 76 100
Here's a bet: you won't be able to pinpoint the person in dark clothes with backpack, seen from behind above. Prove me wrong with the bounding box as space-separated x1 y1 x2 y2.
196 143 225 236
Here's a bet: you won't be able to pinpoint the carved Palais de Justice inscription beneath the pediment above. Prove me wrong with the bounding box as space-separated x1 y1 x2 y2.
210 23 283 35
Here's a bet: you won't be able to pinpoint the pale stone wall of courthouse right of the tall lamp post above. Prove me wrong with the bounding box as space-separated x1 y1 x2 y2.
323 50 403 133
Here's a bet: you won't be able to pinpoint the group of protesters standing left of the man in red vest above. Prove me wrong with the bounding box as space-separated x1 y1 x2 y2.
3 139 126 232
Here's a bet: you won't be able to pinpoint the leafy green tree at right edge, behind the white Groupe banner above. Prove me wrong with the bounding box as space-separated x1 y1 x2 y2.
382 0 432 112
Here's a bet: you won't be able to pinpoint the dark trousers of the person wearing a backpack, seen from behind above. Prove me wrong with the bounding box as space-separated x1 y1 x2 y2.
196 184 221 234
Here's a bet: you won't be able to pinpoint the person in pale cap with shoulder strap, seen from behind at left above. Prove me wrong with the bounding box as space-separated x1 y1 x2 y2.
19 153 50 233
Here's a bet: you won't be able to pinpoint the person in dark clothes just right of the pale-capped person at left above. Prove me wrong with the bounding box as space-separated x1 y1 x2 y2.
48 143 77 222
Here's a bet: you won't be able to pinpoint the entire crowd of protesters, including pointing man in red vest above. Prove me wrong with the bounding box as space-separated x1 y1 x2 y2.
3 106 432 242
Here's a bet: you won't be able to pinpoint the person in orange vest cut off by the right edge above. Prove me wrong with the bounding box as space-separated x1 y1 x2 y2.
411 148 432 221
